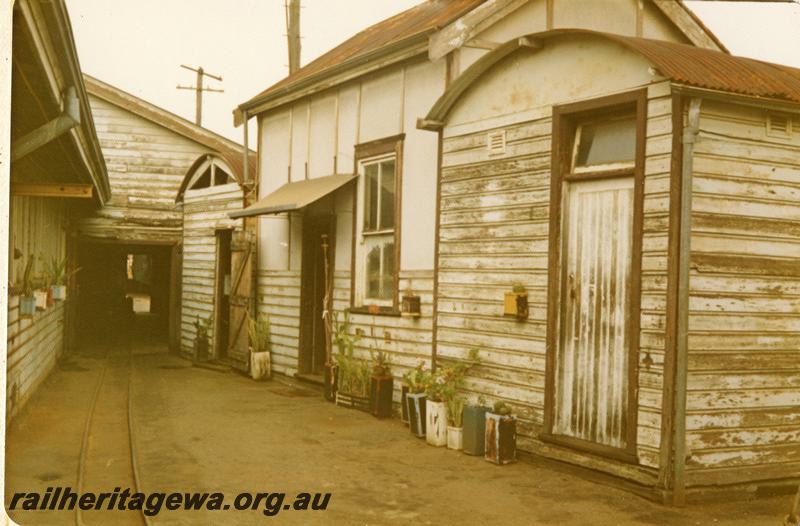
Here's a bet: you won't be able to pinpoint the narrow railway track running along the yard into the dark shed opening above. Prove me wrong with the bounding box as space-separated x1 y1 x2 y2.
75 344 150 526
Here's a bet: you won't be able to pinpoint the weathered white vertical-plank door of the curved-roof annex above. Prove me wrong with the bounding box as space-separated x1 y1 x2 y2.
553 177 634 448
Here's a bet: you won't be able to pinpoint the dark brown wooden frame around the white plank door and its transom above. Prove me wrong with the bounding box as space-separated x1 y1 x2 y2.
540 88 647 464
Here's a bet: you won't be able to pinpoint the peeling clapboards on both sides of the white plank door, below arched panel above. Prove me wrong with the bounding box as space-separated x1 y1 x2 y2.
436 89 672 468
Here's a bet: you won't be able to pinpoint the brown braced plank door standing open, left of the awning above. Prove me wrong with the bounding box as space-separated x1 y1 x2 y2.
227 230 255 370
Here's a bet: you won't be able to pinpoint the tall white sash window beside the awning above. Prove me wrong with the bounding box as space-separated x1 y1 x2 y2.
356 152 398 307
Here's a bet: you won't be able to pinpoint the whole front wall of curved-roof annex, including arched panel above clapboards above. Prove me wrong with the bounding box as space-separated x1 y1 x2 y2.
437 38 672 485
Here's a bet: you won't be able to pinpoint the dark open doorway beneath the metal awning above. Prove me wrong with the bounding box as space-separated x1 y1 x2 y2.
299 215 335 376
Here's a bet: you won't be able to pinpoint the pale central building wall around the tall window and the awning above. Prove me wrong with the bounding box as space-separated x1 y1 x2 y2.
258 60 445 392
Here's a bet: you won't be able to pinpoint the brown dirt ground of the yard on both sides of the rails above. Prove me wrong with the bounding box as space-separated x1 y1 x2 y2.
6 349 790 526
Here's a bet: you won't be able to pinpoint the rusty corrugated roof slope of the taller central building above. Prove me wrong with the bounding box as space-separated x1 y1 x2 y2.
242 0 486 111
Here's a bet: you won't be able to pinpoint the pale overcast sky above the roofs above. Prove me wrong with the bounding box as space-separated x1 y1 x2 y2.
66 0 800 148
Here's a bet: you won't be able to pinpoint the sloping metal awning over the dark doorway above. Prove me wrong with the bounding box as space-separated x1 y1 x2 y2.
228 174 356 219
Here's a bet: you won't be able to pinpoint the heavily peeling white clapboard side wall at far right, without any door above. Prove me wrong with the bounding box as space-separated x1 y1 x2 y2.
687 101 800 485
